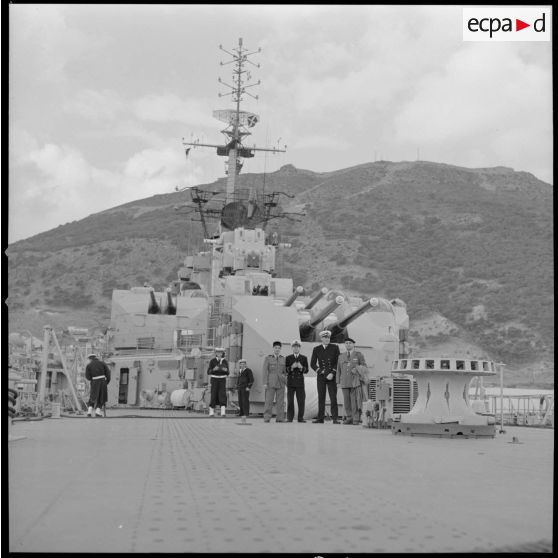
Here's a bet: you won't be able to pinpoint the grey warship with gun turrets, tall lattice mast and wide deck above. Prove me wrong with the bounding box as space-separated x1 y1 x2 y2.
8 39 553 556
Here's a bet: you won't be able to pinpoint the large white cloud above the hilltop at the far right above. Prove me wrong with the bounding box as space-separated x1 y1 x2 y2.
394 44 552 179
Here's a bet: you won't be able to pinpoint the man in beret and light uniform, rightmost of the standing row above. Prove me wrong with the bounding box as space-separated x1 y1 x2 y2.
337 337 366 424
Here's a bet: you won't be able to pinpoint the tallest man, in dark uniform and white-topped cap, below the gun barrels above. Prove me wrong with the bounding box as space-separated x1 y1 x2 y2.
310 329 340 424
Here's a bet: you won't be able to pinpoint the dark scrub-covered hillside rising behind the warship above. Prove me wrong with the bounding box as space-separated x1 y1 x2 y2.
7 161 554 385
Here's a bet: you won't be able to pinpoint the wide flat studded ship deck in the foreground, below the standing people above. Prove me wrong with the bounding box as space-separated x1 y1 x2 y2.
8 410 554 556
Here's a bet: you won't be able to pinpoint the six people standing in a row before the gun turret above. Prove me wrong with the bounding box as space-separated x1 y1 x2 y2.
208 330 367 424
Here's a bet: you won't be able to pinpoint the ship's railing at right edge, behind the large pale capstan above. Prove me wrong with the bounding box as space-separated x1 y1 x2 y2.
470 394 554 428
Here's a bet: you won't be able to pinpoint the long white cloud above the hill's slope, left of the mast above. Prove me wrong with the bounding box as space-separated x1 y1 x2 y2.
9 138 210 242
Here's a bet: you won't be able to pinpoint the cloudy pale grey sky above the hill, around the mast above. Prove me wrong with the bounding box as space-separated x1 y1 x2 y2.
8 4 553 243
